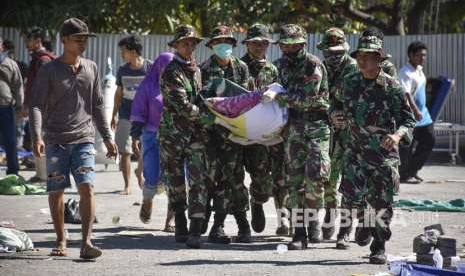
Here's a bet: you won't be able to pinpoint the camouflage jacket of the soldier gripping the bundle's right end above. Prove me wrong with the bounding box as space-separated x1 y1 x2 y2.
275 50 329 113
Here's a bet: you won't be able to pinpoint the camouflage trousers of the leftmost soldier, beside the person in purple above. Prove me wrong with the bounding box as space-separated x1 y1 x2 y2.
160 130 209 218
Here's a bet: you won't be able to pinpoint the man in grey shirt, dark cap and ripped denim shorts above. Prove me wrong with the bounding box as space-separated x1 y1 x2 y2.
30 18 117 259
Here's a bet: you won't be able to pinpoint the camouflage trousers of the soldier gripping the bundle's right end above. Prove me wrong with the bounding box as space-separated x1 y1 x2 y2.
285 121 331 209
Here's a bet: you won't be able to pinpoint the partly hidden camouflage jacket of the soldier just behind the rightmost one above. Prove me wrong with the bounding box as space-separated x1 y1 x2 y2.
323 55 358 110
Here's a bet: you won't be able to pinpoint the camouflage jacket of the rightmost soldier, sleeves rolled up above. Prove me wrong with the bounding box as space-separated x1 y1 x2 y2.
343 70 415 159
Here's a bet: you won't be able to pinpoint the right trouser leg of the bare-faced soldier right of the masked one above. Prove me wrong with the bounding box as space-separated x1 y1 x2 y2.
267 143 289 209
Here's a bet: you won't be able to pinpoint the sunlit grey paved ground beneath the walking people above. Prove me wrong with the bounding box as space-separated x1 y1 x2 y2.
0 166 465 276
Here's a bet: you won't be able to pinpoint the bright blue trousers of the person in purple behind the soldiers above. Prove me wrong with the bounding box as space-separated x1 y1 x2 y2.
140 130 160 199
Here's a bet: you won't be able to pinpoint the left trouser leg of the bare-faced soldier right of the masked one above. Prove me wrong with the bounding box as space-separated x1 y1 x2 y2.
243 145 273 204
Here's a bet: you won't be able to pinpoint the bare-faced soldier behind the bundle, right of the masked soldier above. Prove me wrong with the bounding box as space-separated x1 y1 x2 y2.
242 24 289 235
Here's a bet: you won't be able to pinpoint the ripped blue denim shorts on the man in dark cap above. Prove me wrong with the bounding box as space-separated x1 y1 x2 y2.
45 143 95 192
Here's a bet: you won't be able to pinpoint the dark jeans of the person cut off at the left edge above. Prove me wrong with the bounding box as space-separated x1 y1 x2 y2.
0 106 19 174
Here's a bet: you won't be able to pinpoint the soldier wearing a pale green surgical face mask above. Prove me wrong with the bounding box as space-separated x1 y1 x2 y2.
201 25 251 244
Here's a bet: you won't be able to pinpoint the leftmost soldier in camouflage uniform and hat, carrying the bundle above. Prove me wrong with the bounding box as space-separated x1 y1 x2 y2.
159 25 208 248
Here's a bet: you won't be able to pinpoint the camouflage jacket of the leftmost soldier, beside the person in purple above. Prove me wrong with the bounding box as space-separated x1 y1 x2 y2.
160 55 201 134
